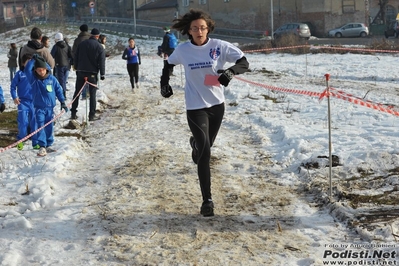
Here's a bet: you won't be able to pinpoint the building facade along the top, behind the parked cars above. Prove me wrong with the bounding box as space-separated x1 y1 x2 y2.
136 0 399 37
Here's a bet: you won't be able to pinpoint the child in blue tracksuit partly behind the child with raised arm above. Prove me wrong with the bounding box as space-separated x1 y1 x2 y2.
10 54 40 150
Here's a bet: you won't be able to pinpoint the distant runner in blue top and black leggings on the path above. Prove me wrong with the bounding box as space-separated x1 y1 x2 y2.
122 38 141 90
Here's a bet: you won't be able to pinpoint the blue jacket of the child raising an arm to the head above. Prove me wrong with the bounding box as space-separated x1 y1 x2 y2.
24 59 65 109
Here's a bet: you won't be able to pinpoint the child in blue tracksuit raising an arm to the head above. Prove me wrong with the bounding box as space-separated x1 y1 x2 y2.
25 54 68 156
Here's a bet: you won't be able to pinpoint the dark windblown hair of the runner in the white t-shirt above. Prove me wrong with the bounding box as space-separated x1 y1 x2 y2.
172 9 215 40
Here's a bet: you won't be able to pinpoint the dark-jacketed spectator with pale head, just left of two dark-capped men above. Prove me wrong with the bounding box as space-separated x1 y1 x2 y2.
51 32 72 98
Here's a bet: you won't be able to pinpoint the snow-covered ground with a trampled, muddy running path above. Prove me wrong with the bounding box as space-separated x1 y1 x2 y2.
0 25 399 266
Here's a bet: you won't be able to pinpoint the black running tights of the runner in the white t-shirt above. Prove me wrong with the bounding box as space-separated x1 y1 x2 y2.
187 103 225 201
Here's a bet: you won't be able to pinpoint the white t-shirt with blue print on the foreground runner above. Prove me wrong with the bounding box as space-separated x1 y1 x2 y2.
168 39 244 110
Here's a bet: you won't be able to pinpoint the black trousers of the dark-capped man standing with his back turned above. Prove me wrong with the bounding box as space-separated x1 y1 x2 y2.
71 71 98 118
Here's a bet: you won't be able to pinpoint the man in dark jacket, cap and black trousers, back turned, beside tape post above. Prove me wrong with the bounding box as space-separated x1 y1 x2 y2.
71 28 105 121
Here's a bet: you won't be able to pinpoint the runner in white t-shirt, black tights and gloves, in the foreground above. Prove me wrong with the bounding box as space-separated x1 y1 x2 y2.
161 9 249 216
